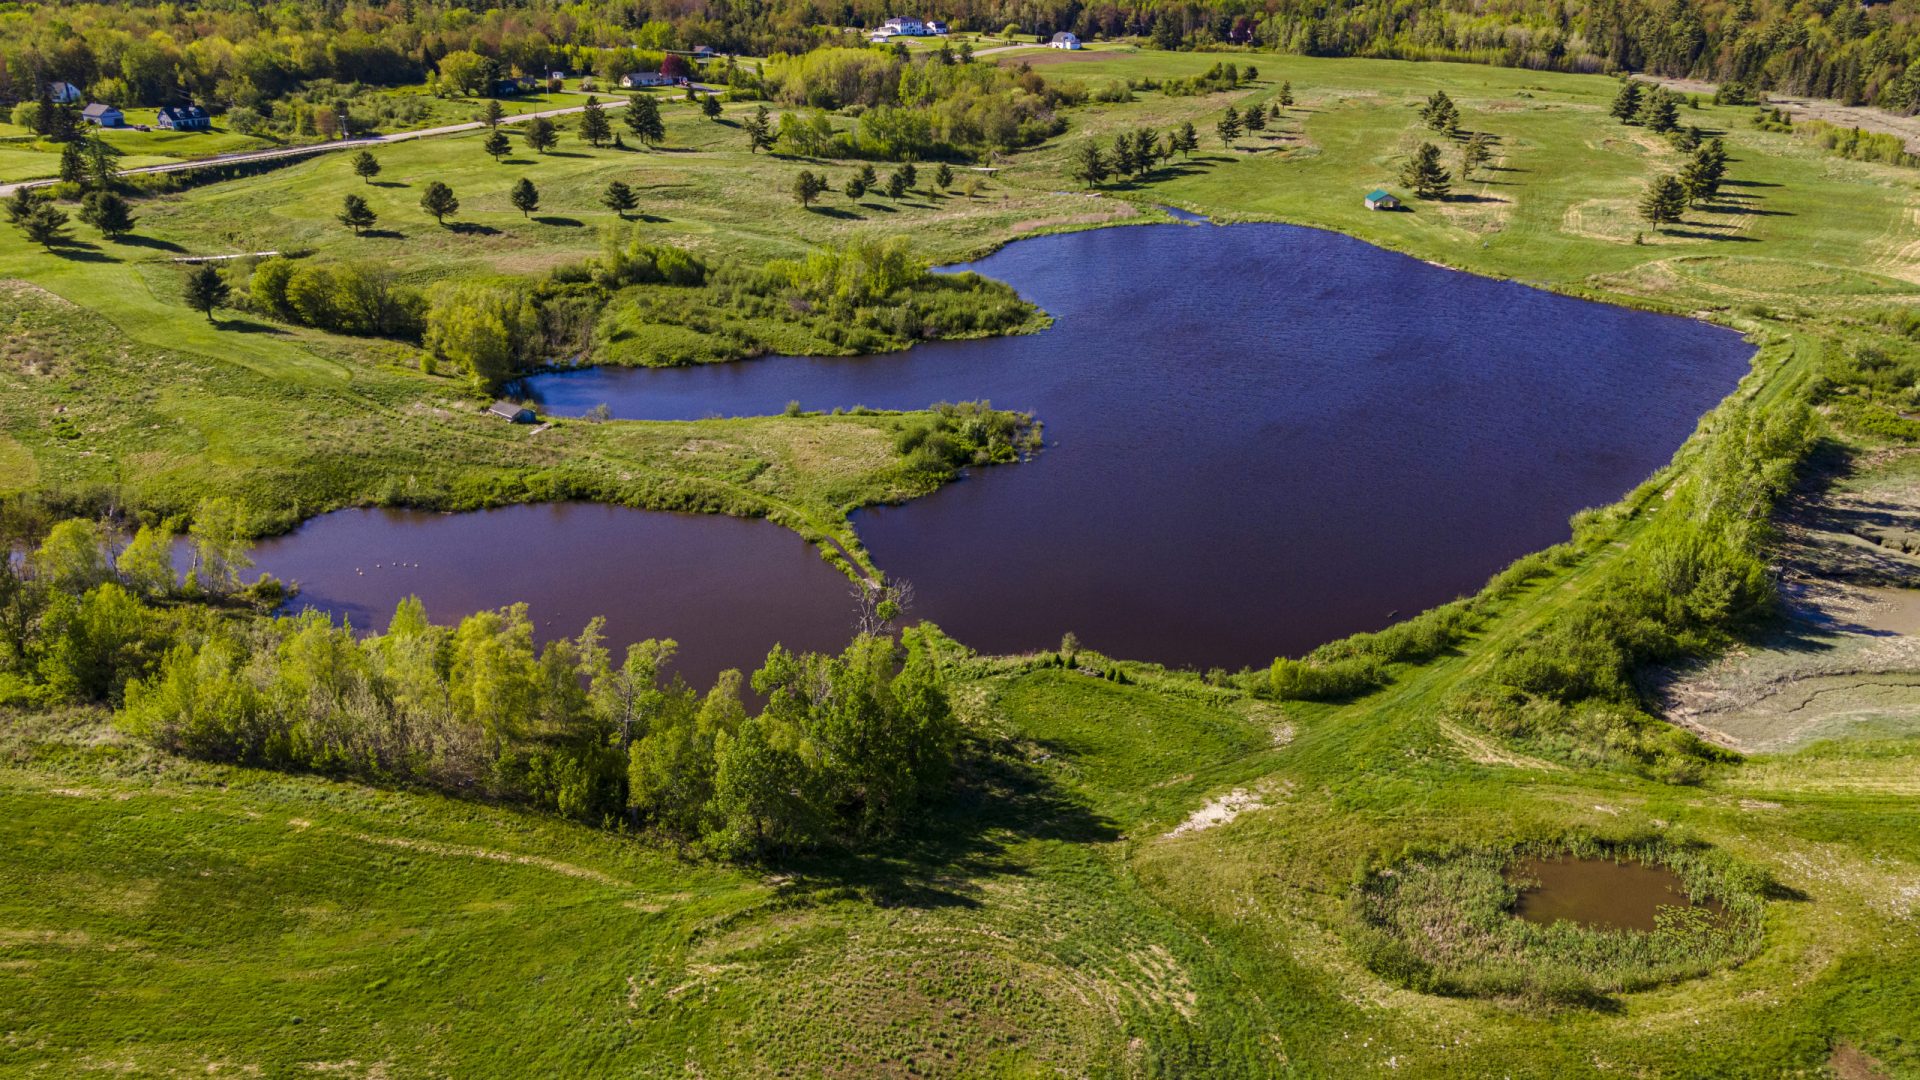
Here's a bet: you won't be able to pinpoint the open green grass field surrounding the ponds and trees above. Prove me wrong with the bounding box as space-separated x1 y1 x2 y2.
0 50 1920 1078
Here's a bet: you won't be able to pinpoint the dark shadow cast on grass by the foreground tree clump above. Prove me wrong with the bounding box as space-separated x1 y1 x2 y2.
764 730 1121 909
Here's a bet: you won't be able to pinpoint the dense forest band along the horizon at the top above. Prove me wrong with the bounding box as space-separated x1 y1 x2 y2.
0 0 1920 111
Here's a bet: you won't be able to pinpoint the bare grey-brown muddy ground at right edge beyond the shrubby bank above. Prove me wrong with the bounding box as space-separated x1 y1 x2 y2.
1649 450 1920 753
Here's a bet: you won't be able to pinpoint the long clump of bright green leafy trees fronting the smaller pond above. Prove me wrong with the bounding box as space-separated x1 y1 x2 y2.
119 598 956 857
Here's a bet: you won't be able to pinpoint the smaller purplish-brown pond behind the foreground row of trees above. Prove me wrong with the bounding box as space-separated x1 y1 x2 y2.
253 503 852 688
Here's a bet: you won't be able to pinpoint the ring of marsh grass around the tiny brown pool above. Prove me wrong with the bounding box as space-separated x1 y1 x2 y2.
1350 838 1768 1007
